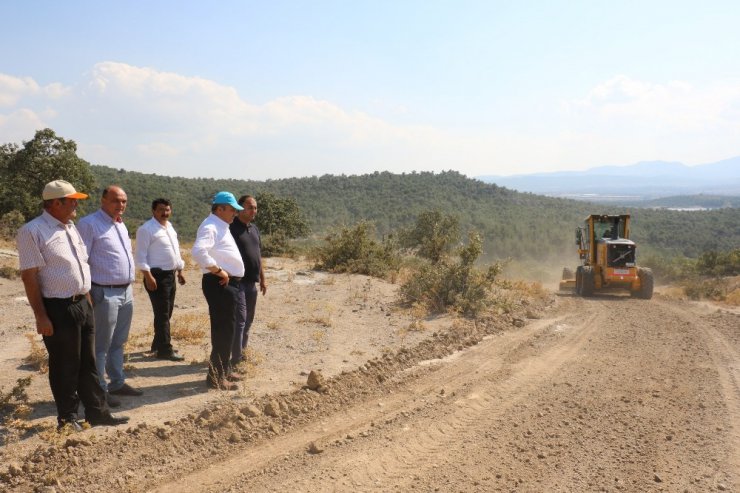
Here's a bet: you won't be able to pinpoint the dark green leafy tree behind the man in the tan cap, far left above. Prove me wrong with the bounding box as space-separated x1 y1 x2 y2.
0 128 95 221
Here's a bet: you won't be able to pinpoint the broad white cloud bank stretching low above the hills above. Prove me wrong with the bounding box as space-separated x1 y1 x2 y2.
0 62 740 179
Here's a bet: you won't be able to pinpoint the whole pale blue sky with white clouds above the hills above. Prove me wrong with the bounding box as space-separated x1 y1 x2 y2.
0 0 740 180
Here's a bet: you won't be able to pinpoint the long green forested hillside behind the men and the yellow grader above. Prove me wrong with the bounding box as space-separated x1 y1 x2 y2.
88 166 740 259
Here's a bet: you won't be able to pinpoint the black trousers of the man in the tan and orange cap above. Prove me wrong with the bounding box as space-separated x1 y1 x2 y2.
44 298 110 423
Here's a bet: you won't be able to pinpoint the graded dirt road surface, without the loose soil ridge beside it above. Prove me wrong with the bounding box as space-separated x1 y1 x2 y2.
149 296 740 492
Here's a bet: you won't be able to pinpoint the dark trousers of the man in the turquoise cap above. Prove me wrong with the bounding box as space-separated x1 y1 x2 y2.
202 274 239 380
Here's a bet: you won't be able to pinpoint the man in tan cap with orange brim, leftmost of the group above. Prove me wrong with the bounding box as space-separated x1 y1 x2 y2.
16 180 128 431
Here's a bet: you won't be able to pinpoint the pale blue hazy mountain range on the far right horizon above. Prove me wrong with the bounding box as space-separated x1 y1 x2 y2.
477 156 740 202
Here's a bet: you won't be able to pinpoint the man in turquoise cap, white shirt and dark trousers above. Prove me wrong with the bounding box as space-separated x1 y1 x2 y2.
192 192 244 390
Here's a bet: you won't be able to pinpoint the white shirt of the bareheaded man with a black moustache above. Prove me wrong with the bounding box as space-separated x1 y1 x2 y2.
134 218 185 271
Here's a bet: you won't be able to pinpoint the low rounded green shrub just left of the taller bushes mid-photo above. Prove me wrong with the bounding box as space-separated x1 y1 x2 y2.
315 221 400 278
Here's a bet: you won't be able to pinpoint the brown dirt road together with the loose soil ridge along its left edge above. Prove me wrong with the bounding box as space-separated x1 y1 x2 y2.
2 286 740 492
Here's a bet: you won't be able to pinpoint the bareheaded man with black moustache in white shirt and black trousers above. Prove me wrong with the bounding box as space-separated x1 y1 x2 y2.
134 198 185 361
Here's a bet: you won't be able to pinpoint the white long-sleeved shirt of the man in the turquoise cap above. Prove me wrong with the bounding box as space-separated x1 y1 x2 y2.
192 214 244 277
